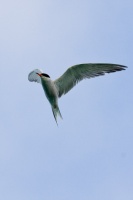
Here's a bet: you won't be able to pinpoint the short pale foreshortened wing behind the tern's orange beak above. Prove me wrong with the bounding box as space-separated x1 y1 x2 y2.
28 69 42 83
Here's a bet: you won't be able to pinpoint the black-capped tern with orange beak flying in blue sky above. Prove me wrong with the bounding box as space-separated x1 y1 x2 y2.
28 63 127 125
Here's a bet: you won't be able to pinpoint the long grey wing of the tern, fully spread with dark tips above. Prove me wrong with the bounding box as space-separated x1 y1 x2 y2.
54 63 126 97
